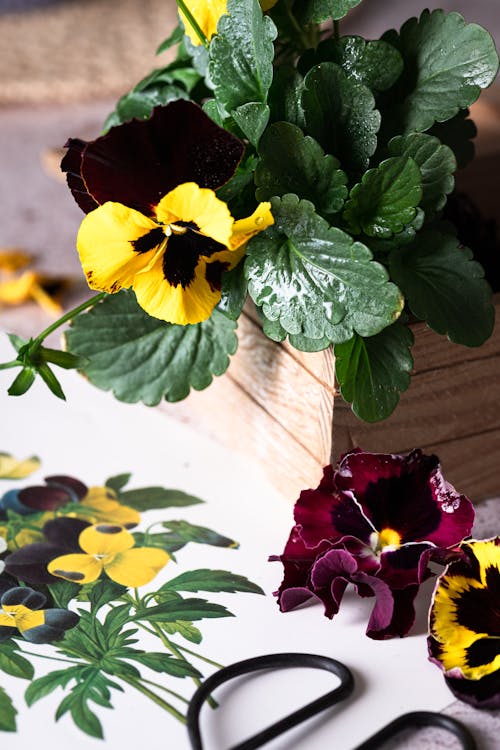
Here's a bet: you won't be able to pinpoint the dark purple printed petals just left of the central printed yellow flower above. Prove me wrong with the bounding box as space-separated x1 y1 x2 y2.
5 516 90 584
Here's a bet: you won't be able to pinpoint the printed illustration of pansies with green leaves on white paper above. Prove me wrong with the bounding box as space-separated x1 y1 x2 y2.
0 453 263 738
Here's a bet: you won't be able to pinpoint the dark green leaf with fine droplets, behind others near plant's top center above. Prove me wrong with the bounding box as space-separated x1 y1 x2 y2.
299 36 403 91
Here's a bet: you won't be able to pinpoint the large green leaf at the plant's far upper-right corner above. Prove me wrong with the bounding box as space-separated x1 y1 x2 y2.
383 10 498 134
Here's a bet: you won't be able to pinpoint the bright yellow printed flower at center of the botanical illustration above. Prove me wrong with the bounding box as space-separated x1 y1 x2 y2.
47 524 170 588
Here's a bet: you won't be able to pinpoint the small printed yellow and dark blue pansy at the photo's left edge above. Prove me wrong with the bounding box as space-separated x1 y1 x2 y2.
0 586 79 643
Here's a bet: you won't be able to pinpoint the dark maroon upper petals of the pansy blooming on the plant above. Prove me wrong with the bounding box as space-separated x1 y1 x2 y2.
61 99 244 216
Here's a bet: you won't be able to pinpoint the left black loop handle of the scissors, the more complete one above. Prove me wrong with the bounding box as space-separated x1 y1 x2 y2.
187 654 354 750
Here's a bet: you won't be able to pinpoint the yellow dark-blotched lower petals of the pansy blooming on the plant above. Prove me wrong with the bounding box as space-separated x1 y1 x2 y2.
77 182 274 325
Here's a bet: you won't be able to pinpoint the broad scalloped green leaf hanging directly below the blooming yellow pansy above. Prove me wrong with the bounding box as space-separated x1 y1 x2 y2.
66 291 238 406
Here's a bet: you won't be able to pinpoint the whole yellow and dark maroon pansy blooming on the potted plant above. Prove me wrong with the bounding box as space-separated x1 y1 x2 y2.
61 100 274 325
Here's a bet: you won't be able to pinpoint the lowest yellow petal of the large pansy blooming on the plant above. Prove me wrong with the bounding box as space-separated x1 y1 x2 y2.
134 251 221 325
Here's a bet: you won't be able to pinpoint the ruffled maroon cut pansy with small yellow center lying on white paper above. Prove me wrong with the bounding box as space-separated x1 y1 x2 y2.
271 449 474 639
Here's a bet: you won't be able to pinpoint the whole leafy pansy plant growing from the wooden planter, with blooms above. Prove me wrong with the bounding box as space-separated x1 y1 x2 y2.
0 0 498 421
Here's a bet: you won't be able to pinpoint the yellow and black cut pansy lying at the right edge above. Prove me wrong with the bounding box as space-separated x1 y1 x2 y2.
428 537 500 708
